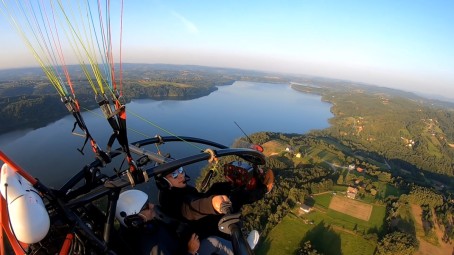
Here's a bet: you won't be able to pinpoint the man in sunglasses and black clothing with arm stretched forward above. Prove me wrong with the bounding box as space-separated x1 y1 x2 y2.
156 168 274 254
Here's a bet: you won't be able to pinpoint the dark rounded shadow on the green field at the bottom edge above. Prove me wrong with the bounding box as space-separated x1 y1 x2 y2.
300 221 342 255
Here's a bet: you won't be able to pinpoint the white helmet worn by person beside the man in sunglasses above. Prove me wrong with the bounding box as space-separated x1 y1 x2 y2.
115 189 148 226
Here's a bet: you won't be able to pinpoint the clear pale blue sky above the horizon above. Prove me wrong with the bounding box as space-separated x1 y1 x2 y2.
0 0 454 98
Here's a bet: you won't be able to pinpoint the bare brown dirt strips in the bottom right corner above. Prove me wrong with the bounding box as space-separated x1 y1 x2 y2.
411 204 454 255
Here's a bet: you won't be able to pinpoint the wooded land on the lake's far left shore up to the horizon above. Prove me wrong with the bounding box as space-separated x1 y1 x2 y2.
0 64 288 133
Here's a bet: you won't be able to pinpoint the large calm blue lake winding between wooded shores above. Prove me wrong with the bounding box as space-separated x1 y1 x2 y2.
0 82 333 187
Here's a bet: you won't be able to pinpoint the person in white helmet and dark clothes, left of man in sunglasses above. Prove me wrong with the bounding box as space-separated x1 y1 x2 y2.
115 190 200 255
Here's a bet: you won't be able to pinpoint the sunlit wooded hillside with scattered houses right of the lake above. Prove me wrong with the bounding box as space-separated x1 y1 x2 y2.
323 90 454 180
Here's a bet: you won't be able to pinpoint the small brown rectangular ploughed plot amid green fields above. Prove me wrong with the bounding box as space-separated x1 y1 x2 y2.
329 196 373 221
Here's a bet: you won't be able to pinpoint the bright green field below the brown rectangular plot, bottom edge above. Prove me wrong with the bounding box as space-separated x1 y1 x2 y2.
256 192 386 255
